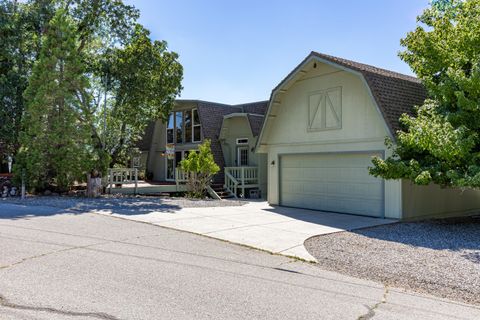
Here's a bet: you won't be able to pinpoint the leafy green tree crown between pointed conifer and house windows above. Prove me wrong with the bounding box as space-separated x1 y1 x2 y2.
105 24 183 165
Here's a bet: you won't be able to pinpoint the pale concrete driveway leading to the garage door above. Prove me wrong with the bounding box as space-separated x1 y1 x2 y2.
96 202 395 261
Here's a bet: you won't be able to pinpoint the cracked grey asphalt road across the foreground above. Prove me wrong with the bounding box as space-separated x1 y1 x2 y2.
0 201 480 320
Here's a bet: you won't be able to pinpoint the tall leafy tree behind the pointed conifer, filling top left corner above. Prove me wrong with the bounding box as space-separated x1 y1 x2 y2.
0 0 139 163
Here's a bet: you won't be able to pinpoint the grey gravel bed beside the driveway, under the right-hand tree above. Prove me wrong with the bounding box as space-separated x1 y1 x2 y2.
305 217 480 305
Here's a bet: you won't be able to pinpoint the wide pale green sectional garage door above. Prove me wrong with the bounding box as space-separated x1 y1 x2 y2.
280 153 384 217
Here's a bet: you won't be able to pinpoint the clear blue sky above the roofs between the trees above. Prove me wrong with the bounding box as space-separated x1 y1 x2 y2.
125 0 429 104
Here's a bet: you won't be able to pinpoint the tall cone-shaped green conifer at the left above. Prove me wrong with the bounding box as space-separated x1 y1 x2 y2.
15 10 92 191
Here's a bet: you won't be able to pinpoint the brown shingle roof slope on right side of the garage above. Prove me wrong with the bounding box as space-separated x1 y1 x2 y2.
309 52 427 134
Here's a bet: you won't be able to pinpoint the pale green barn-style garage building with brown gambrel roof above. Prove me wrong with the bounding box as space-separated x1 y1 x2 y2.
256 52 480 219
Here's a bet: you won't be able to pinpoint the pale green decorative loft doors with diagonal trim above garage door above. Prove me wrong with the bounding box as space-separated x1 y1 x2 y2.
307 87 342 131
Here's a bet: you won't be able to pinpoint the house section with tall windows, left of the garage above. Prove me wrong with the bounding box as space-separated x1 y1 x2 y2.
138 100 268 197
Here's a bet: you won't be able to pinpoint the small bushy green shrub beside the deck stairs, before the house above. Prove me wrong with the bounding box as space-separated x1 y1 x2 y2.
180 139 220 198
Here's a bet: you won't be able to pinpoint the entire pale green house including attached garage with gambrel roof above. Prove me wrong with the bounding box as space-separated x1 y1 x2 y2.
140 52 480 219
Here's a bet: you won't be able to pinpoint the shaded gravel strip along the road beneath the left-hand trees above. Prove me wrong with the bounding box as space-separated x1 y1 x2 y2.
0 195 245 213
